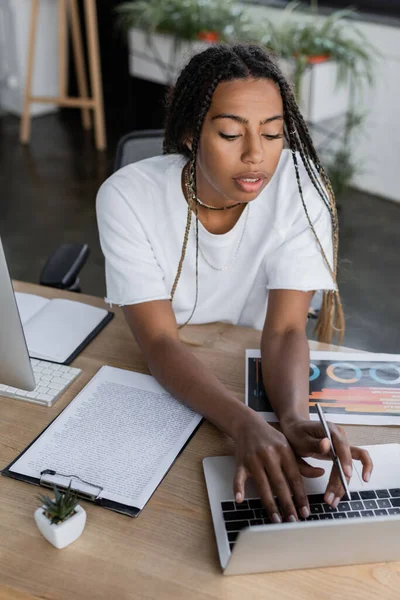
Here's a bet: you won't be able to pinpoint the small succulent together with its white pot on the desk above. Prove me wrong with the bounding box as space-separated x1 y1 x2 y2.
34 484 86 548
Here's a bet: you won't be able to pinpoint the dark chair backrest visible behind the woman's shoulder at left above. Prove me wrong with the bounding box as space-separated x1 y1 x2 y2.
114 129 164 171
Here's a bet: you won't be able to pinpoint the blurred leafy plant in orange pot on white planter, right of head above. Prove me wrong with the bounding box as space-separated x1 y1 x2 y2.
261 0 376 121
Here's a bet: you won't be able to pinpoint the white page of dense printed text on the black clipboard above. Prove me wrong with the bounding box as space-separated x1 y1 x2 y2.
10 366 202 509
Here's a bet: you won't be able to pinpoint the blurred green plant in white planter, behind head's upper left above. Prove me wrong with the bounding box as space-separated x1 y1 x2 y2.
116 0 253 84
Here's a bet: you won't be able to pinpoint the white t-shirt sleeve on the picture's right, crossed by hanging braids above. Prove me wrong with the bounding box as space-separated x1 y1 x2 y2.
267 176 336 292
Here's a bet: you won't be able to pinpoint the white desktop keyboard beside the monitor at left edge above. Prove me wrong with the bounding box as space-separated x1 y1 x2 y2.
0 358 82 406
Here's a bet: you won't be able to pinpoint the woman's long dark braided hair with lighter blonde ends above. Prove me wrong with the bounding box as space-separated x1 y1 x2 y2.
163 43 344 343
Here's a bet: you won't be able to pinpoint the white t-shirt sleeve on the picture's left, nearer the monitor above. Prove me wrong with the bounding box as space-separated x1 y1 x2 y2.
96 173 171 306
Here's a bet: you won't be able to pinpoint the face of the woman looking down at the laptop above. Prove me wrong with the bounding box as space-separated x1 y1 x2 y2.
191 79 283 206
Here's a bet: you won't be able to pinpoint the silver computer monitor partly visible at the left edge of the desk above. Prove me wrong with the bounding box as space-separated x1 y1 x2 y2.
0 238 36 395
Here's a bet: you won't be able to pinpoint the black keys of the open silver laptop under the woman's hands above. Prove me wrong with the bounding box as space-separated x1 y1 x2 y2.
221 488 400 550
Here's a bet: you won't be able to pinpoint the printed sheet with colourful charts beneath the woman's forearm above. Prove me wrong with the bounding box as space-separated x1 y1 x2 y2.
246 350 400 425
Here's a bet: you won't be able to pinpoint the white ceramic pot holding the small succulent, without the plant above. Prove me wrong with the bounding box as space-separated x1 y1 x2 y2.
34 504 86 548
